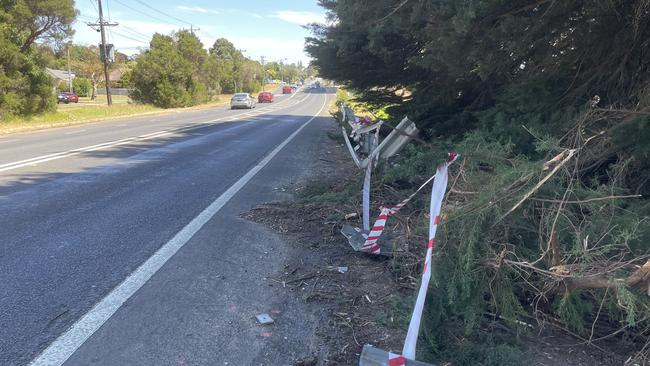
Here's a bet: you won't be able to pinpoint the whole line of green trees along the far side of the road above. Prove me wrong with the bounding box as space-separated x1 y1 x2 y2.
0 0 313 119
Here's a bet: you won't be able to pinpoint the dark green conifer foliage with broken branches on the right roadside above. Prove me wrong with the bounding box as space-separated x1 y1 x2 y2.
306 0 650 364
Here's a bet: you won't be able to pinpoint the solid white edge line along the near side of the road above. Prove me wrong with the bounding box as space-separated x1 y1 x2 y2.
30 93 327 366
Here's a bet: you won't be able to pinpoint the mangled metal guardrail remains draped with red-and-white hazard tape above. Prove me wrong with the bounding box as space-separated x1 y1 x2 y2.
341 101 458 366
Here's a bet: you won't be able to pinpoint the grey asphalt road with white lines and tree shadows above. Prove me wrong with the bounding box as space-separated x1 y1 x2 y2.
0 90 333 366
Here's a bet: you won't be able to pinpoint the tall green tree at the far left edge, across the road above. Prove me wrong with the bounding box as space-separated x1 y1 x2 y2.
0 0 76 120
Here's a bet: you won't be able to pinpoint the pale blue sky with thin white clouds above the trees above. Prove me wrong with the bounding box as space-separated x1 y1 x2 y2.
74 0 325 64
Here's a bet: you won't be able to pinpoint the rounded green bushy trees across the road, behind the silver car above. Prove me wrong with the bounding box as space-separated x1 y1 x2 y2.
126 31 303 108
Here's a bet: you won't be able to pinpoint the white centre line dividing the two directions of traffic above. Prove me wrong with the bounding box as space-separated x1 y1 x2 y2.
0 89 306 173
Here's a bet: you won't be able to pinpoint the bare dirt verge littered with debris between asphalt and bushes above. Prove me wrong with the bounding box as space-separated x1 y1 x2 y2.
242 123 626 366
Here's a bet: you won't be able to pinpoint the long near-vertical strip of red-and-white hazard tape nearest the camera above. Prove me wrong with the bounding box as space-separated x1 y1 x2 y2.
388 153 458 366
